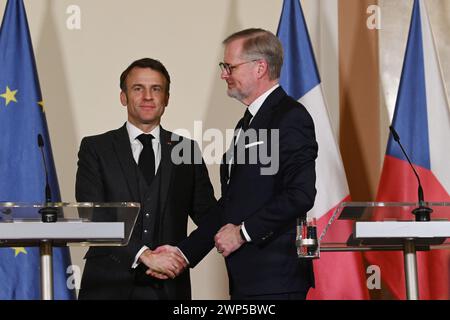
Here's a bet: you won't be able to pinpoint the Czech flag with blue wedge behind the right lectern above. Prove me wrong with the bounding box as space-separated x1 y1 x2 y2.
366 0 450 299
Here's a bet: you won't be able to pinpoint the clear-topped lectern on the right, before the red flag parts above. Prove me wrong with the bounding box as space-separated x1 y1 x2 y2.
312 202 450 300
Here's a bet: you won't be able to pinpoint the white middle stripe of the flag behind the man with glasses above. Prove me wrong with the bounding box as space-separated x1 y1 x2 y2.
299 84 349 218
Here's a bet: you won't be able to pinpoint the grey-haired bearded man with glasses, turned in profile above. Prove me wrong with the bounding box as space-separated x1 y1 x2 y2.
172 29 318 299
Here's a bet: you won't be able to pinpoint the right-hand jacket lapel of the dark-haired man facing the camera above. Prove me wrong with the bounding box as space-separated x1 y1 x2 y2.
159 127 175 214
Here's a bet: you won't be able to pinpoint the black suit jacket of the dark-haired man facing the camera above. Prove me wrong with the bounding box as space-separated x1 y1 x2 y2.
76 125 216 299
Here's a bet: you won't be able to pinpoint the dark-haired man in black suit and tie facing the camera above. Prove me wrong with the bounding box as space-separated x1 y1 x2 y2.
76 58 216 299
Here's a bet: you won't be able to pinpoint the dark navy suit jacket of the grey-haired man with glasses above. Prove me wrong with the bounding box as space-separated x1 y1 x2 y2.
179 87 318 295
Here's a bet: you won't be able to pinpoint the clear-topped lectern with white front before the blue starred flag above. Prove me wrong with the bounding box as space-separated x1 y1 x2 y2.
0 202 140 300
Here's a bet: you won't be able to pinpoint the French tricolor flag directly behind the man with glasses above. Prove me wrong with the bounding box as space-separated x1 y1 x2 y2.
277 0 368 299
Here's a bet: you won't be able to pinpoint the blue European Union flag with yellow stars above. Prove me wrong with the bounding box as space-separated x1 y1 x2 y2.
0 0 74 299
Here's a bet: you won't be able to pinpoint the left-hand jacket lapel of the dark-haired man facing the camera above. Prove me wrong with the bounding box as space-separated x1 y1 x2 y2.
113 125 141 201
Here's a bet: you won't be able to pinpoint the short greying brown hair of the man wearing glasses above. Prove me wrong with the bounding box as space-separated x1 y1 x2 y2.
223 28 283 80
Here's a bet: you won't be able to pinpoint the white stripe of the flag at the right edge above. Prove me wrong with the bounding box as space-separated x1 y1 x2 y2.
420 1 450 194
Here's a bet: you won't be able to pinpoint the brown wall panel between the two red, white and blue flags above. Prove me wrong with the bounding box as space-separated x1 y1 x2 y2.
338 0 380 201
